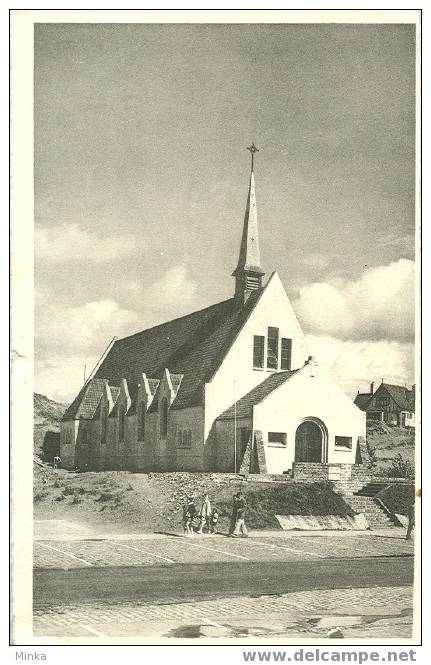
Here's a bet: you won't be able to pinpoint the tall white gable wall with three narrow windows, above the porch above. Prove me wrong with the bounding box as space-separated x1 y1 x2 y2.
205 273 306 443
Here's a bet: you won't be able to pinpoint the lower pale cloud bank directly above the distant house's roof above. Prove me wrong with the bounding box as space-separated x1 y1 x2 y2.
306 335 414 395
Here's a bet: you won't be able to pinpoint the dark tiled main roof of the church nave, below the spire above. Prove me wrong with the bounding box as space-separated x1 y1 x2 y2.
64 286 266 420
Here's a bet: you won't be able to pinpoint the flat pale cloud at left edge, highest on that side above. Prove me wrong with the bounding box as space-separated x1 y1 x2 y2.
35 224 142 263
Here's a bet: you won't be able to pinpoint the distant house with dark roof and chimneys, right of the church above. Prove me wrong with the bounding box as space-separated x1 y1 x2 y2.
355 379 415 427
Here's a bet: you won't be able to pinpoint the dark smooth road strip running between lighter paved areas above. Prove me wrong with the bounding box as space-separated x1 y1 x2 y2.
33 556 413 609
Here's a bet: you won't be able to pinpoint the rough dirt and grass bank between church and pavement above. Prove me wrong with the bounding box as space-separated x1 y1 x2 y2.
34 467 352 532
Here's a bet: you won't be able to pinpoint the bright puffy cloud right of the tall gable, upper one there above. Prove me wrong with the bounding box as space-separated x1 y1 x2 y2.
293 259 414 342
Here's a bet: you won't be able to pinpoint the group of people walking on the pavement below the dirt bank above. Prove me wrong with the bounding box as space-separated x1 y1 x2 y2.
183 492 248 538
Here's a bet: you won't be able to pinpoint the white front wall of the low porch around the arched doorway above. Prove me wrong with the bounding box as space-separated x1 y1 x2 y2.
253 366 366 473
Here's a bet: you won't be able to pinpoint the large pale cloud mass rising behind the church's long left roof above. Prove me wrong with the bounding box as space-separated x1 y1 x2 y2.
35 265 196 402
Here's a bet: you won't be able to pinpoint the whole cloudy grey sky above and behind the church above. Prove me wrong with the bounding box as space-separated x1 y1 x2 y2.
34 24 415 402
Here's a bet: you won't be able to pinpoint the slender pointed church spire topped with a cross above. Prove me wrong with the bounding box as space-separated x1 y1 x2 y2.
232 143 265 304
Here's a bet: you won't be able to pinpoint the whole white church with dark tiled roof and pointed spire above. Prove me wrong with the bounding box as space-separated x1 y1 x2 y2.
61 160 366 473
